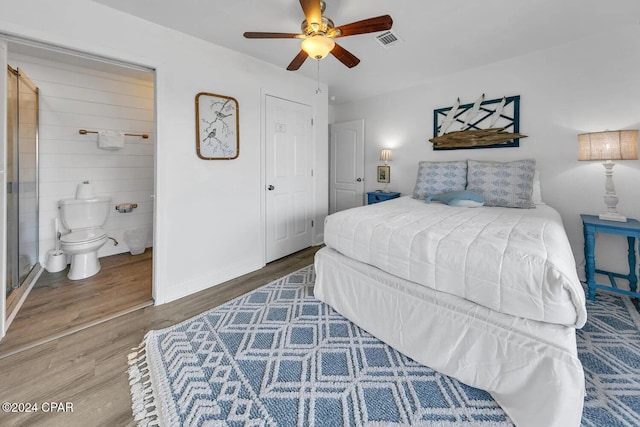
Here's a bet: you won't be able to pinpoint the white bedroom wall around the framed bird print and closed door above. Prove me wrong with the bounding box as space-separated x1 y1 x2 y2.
0 0 328 303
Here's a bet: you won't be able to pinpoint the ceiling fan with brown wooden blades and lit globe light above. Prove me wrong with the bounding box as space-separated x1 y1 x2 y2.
244 0 393 71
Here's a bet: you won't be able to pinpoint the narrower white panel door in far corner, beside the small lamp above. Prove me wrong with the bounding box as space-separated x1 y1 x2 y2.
329 120 364 213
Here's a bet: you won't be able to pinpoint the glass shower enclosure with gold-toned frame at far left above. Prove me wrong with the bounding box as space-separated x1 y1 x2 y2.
5 66 40 319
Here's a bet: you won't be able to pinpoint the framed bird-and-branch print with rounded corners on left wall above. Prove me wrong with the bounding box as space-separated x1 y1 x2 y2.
196 92 240 160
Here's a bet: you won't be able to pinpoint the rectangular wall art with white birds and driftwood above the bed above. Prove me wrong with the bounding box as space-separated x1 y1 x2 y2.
429 94 526 150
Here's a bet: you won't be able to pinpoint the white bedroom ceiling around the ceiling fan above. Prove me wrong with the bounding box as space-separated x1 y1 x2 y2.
94 0 640 103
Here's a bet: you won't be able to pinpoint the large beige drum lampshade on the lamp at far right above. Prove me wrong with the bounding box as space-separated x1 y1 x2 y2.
578 130 638 160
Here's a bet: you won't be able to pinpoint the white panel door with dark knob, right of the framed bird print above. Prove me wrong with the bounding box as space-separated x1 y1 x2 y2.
265 96 313 262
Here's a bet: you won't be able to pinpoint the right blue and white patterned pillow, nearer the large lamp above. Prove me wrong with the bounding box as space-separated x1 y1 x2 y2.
467 159 536 208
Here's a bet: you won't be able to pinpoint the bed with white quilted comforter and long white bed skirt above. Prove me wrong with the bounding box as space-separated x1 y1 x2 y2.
314 162 586 427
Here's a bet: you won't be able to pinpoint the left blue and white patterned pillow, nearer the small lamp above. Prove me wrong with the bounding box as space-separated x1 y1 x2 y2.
413 160 467 200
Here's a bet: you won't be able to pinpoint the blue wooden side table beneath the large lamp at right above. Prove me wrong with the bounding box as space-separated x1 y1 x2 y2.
580 214 640 299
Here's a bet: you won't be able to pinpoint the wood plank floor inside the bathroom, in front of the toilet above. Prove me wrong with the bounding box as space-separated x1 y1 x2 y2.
0 249 153 358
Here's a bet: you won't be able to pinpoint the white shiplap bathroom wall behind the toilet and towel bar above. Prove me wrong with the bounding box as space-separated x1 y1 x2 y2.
9 54 155 265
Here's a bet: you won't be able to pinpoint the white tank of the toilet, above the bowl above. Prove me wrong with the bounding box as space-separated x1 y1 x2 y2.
58 196 111 230
